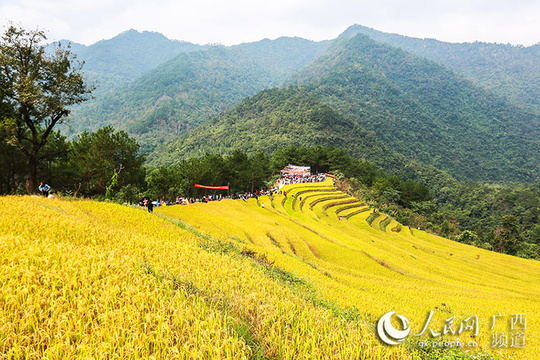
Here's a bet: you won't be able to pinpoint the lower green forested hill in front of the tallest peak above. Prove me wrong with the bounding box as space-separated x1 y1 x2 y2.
148 85 470 218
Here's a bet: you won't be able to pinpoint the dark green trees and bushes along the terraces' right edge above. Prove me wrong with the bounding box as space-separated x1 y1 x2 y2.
338 168 540 260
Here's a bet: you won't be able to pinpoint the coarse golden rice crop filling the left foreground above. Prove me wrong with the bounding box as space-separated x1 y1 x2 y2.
0 197 407 359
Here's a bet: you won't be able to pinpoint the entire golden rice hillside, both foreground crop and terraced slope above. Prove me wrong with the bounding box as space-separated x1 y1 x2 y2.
0 183 540 359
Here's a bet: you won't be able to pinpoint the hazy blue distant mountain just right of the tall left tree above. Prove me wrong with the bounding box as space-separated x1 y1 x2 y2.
54 30 208 95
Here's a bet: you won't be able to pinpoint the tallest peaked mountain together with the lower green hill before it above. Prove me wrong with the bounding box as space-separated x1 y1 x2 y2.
151 35 540 182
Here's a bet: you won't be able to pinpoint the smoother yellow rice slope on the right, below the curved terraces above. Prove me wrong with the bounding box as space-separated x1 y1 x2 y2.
159 180 540 359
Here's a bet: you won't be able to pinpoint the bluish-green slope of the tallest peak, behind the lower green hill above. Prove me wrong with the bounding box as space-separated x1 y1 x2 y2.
284 35 540 182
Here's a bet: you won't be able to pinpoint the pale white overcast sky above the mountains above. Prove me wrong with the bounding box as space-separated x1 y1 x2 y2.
0 0 540 45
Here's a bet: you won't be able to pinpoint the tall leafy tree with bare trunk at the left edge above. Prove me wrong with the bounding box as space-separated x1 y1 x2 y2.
0 25 93 194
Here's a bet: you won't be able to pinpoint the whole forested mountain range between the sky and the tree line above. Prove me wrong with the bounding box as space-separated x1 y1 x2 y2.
56 26 540 182
